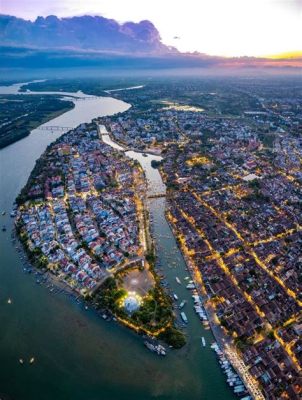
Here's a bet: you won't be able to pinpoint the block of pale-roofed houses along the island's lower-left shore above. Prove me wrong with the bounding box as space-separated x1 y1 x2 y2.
20 200 105 291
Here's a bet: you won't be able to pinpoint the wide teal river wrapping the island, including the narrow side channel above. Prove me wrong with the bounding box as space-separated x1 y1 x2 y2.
0 85 234 400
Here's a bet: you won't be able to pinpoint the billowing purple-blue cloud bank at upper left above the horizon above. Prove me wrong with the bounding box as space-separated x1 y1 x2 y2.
0 14 177 54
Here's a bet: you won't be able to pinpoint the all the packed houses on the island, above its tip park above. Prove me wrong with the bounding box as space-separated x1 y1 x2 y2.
16 125 142 294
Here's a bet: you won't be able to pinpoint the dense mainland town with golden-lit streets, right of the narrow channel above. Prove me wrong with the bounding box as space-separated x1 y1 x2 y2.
103 81 302 399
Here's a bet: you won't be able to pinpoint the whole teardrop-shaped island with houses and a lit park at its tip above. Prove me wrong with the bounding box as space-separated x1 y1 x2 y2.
16 123 185 354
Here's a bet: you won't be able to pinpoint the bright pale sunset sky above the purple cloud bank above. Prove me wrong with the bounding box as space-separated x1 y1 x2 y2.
0 0 302 56
